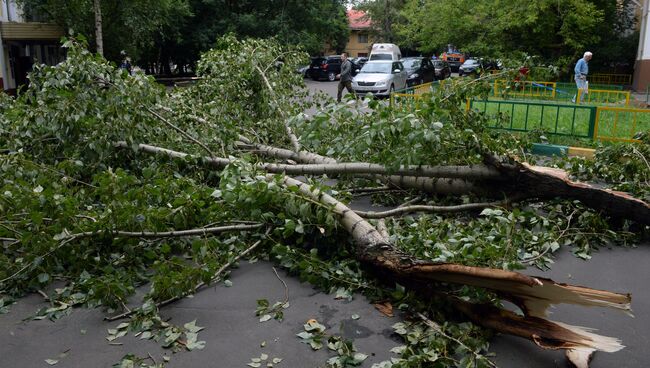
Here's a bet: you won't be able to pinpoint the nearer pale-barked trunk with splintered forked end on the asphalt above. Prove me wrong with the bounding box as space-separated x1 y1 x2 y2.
276 175 631 361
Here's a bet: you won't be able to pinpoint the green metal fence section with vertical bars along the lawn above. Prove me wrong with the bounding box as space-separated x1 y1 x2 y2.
469 100 596 139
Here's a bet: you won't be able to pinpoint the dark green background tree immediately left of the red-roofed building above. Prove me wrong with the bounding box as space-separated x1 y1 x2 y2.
152 0 349 73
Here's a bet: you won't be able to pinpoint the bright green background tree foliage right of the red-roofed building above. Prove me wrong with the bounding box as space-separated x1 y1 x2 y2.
394 0 638 74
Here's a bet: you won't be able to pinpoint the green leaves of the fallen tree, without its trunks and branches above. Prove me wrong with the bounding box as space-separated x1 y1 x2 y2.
0 36 649 367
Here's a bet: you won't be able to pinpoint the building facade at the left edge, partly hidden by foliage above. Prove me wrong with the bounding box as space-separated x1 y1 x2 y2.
0 0 64 92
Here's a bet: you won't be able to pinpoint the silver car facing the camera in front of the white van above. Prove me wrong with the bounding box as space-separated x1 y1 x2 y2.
352 60 407 96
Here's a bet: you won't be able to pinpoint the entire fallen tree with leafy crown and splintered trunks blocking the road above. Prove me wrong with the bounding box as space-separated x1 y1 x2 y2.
0 37 650 365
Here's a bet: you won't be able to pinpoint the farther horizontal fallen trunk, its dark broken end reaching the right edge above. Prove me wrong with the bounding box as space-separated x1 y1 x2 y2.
121 142 650 225
